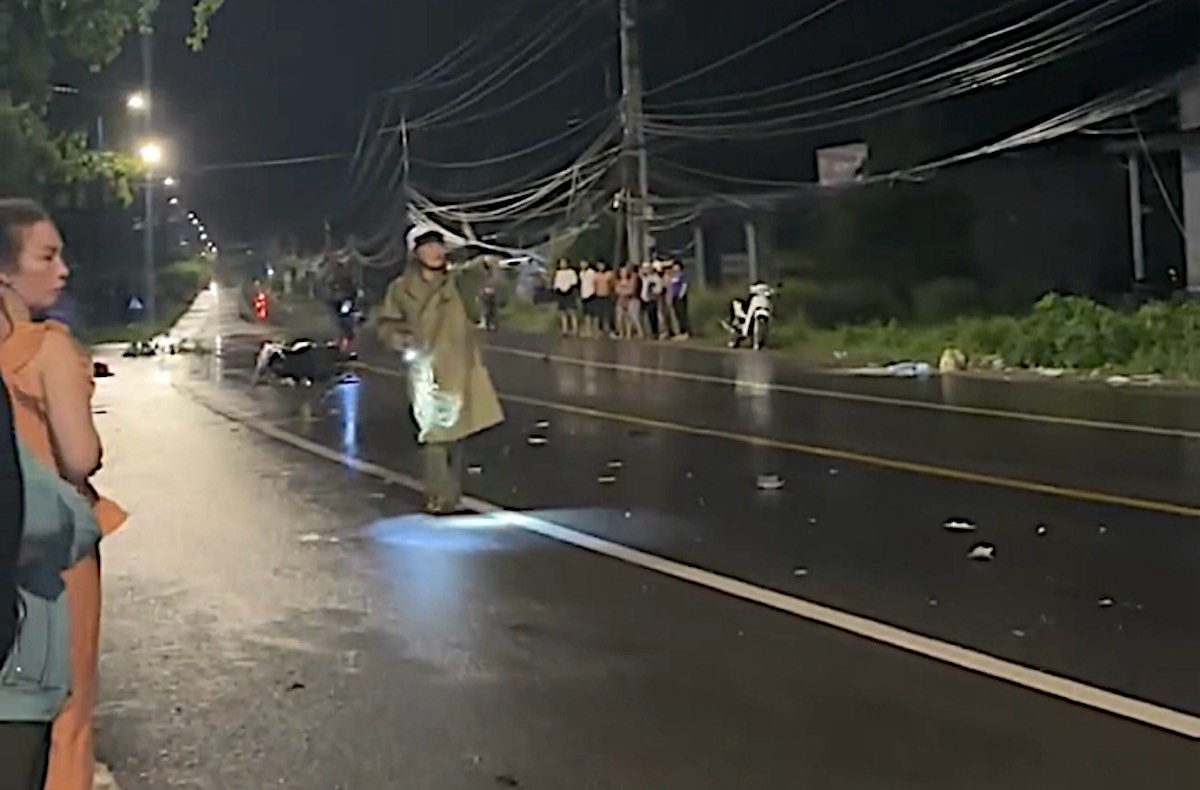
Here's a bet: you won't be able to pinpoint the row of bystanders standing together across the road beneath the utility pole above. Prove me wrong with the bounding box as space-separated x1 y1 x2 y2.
551 261 691 340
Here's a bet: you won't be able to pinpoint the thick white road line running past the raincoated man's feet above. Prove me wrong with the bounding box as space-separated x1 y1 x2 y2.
182 388 1200 740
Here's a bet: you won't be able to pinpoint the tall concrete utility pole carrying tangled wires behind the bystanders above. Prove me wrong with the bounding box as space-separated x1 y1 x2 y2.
619 0 650 263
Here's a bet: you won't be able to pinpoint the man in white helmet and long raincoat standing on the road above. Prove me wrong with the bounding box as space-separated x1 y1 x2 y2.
376 227 504 515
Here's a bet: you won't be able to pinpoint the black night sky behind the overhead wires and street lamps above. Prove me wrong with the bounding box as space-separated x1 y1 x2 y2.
88 0 1200 246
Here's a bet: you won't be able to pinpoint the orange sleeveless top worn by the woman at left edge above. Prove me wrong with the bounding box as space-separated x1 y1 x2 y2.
0 321 128 534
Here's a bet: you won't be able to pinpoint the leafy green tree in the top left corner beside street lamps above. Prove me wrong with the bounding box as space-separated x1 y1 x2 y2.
0 0 224 192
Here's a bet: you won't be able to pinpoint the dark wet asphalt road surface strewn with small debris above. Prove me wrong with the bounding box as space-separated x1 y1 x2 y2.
91 290 1200 790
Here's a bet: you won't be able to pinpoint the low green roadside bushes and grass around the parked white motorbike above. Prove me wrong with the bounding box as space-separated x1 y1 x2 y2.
506 279 1200 381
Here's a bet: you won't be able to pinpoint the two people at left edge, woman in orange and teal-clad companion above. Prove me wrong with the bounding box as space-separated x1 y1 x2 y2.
0 198 126 790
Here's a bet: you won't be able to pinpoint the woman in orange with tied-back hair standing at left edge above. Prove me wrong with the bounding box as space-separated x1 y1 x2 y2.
0 199 126 790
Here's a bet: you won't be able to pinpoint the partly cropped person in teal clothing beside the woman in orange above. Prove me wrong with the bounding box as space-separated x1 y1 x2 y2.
0 381 100 790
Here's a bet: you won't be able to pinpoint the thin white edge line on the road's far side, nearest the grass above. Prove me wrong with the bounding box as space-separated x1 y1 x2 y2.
485 346 1200 439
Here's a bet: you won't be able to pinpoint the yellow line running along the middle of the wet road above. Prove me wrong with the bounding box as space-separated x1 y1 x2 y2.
355 363 1200 519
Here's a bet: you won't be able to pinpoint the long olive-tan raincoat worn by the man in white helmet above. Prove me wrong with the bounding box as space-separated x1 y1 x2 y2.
376 264 504 443
